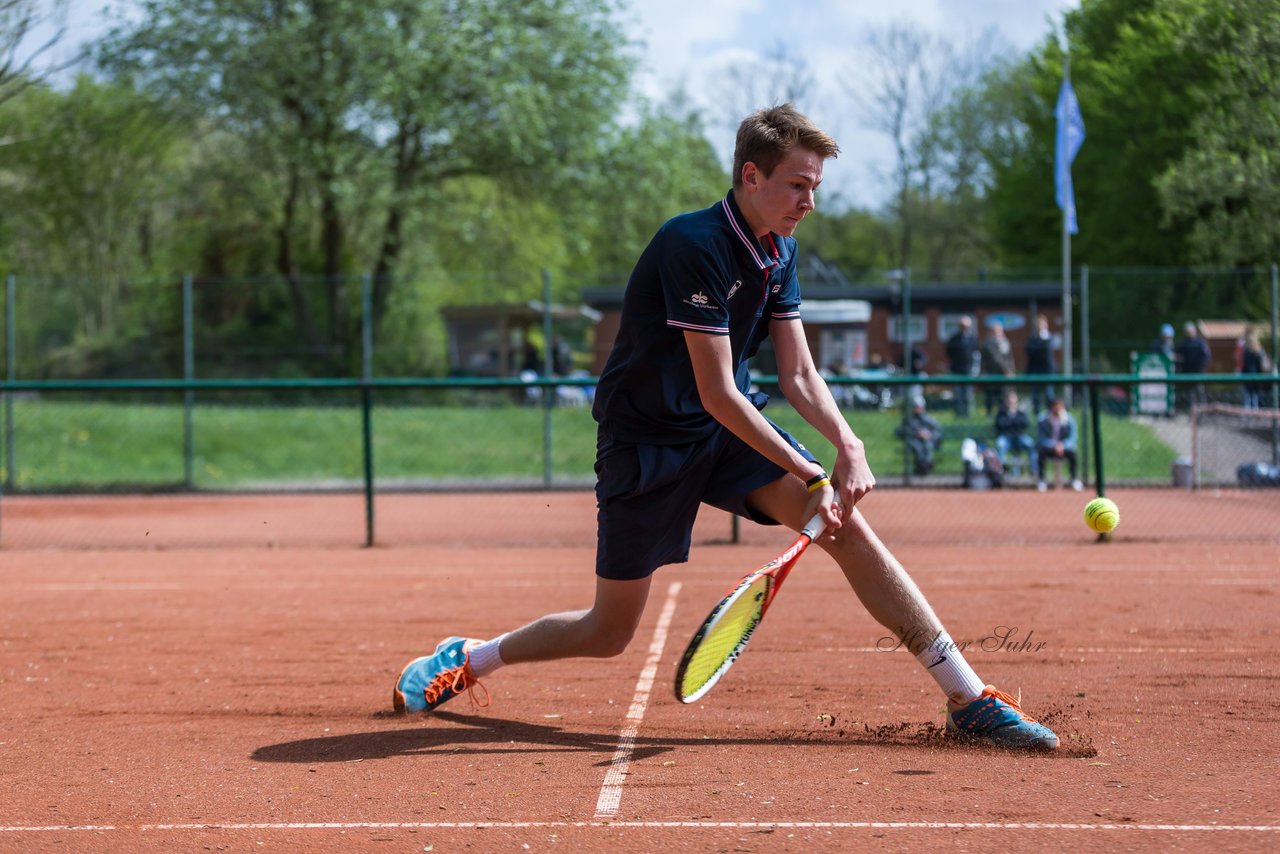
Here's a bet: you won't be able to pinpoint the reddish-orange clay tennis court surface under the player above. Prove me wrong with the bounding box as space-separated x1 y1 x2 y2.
0 490 1280 851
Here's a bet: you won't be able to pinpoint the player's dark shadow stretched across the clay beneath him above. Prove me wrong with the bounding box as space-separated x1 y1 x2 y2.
251 712 938 766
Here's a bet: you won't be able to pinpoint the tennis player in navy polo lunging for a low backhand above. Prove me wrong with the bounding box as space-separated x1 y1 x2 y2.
393 105 1057 749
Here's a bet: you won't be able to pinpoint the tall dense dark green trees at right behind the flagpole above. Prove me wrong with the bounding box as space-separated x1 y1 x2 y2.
988 0 1277 365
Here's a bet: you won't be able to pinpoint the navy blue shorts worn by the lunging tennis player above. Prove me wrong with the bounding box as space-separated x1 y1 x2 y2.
595 421 814 581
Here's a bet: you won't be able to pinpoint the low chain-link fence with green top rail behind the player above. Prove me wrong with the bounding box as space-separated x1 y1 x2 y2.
0 376 1280 547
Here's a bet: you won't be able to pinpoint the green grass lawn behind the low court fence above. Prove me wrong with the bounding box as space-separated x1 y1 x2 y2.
5 394 1176 492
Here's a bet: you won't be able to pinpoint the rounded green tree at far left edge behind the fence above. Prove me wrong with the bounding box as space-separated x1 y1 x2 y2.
0 76 180 366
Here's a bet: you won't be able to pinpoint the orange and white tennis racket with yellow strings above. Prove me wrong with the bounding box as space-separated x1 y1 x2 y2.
676 515 826 703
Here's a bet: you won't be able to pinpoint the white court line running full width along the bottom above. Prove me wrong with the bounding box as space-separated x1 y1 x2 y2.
0 821 1280 834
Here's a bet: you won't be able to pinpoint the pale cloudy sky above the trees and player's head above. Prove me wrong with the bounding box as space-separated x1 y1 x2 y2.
28 0 1079 209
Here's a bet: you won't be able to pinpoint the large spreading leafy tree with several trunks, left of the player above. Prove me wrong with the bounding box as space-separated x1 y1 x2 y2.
101 0 627 357
